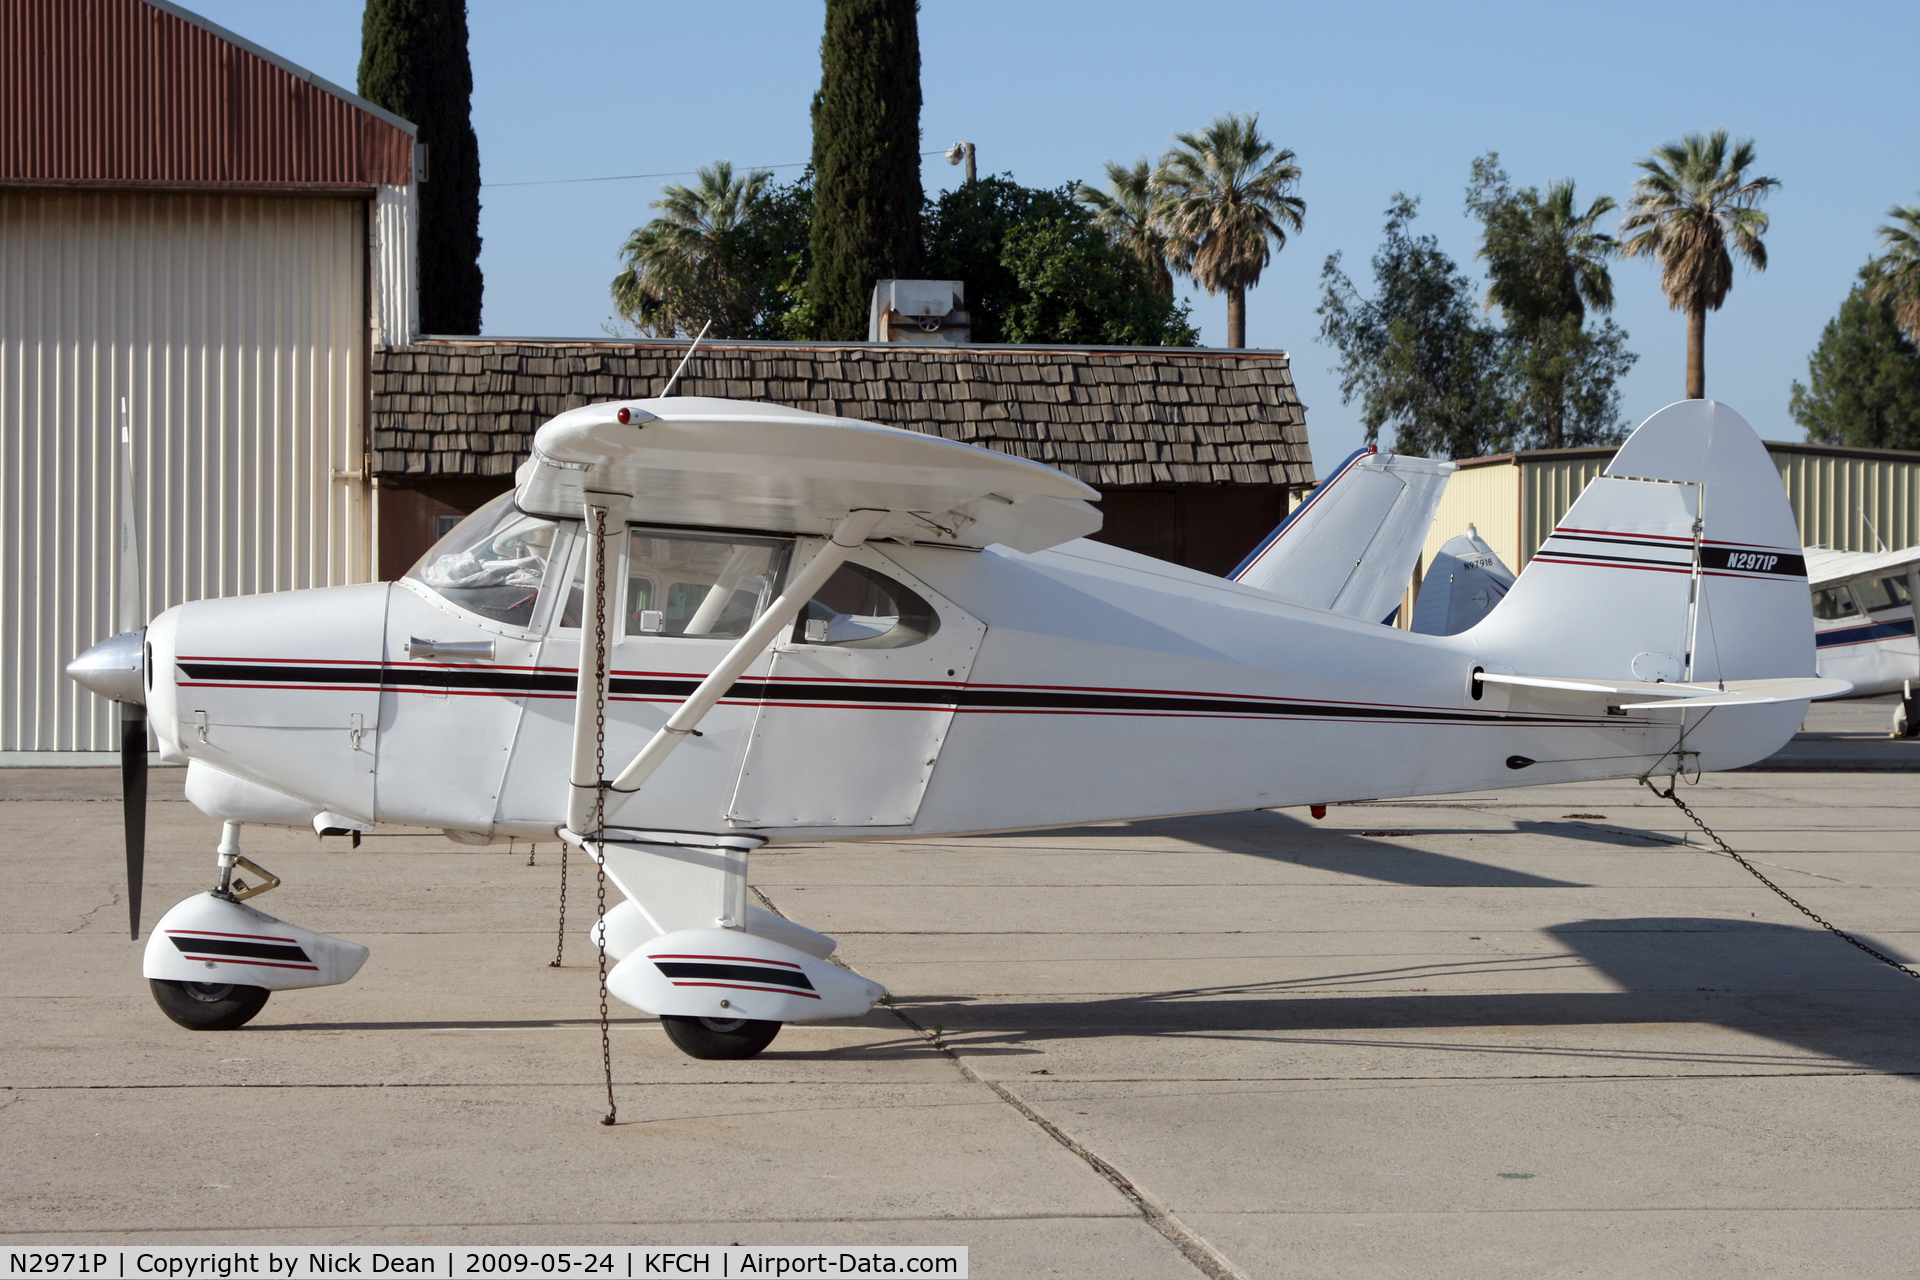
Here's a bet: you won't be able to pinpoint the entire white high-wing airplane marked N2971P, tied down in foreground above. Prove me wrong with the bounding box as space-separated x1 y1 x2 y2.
69 397 1847 1057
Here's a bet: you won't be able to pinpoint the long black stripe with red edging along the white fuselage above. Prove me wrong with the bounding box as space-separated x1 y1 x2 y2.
180 660 1613 723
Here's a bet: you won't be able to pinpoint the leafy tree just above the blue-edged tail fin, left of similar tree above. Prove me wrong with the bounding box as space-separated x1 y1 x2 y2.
1319 194 1509 459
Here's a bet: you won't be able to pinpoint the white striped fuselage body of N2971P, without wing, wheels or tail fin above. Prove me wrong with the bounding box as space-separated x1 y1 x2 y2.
148 499 1801 841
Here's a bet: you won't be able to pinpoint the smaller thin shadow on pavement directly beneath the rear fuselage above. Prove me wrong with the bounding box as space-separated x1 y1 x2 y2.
1050 810 1582 889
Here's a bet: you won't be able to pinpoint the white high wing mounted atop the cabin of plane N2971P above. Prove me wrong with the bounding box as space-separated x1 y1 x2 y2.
515 395 1100 553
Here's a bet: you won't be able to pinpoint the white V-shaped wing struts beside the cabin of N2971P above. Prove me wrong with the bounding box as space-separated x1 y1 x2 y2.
563 503 889 842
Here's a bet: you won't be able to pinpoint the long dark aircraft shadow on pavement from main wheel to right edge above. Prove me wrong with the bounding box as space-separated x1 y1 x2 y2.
899 917 1920 1073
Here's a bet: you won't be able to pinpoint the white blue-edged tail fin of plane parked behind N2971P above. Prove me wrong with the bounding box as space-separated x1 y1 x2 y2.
1229 447 1453 622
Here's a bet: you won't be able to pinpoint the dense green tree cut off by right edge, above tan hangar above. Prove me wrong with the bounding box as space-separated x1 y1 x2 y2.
1788 276 1920 449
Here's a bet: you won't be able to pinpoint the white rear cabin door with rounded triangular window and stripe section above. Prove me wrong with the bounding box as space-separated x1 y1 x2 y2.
728 539 987 827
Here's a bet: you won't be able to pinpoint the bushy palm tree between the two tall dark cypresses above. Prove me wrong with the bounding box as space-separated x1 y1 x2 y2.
611 159 774 338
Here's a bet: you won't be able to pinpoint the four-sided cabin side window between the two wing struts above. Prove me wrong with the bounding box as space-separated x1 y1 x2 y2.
626 530 791 639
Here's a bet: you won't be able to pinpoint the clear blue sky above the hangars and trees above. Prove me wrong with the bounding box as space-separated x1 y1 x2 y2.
188 0 1920 468
